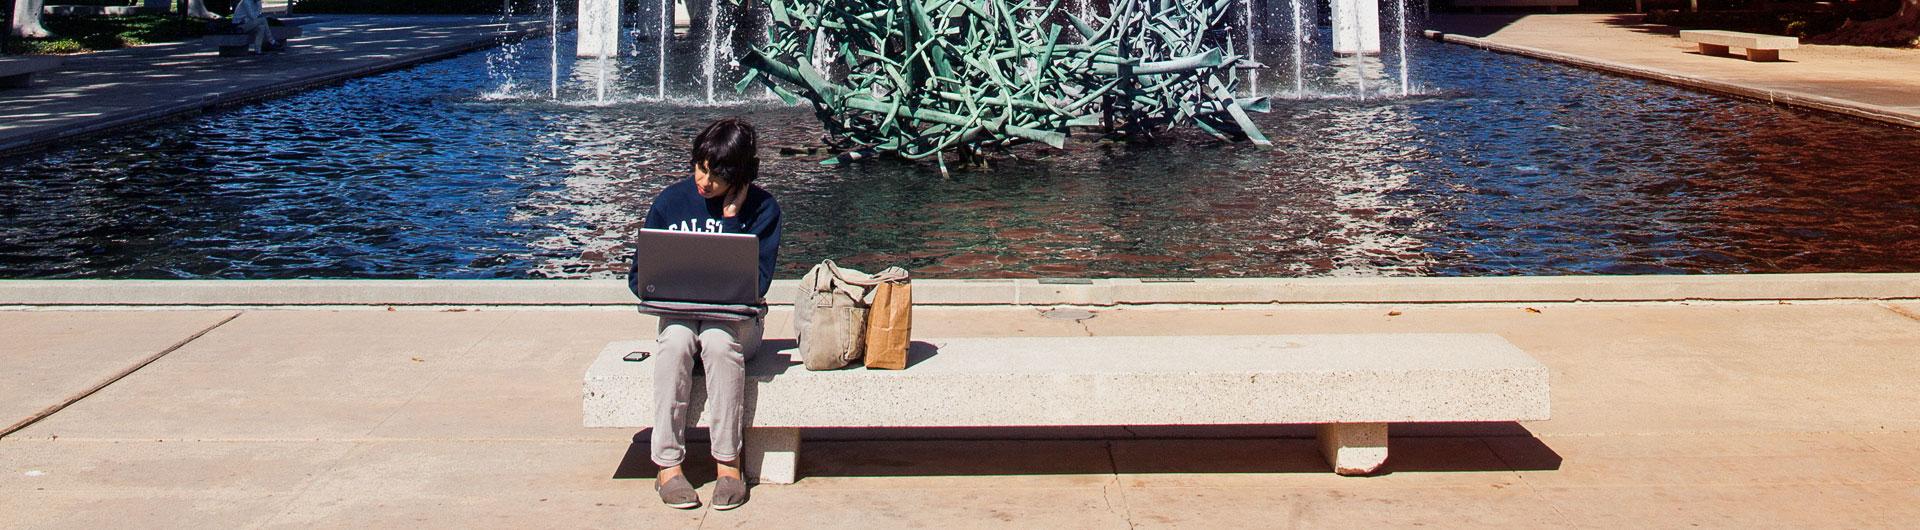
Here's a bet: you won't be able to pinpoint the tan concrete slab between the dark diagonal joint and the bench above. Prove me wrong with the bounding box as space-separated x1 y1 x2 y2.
15 311 507 440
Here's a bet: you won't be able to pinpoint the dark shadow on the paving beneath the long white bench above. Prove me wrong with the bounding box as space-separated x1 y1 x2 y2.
614 422 1561 484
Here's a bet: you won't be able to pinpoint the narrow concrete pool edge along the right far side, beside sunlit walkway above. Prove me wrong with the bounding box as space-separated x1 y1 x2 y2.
1421 29 1920 129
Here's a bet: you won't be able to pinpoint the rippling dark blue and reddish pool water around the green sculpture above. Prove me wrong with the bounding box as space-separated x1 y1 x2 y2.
0 33 1920 278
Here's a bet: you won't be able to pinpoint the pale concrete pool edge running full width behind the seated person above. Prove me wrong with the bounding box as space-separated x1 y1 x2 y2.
0 273 1920 307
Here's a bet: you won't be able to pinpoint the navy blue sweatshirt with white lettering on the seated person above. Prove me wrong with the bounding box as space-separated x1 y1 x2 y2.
626 177 780 298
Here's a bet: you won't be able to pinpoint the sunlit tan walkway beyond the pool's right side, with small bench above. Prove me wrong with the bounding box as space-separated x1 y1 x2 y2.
1427 13 1920 127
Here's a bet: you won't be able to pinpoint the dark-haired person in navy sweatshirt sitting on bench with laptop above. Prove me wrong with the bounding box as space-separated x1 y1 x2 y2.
630 117 780 509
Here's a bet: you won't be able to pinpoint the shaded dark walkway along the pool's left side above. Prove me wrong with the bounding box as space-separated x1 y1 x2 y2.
0 15 547 154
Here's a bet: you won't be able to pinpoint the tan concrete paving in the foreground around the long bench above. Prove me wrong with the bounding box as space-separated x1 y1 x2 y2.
0 295 1920 528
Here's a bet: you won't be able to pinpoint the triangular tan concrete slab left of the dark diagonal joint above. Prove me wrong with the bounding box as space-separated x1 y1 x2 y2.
0 311 236 428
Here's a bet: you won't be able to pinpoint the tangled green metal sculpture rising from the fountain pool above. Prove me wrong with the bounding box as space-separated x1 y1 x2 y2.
735 0 1269 169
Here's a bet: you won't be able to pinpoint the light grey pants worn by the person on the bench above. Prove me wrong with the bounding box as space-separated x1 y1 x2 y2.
653 319 766 467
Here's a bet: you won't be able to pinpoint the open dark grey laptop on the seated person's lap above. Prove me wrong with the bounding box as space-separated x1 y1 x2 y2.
632 229 760 303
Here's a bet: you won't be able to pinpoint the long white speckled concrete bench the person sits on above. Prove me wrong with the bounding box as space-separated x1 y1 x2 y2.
582 334 1549 484
